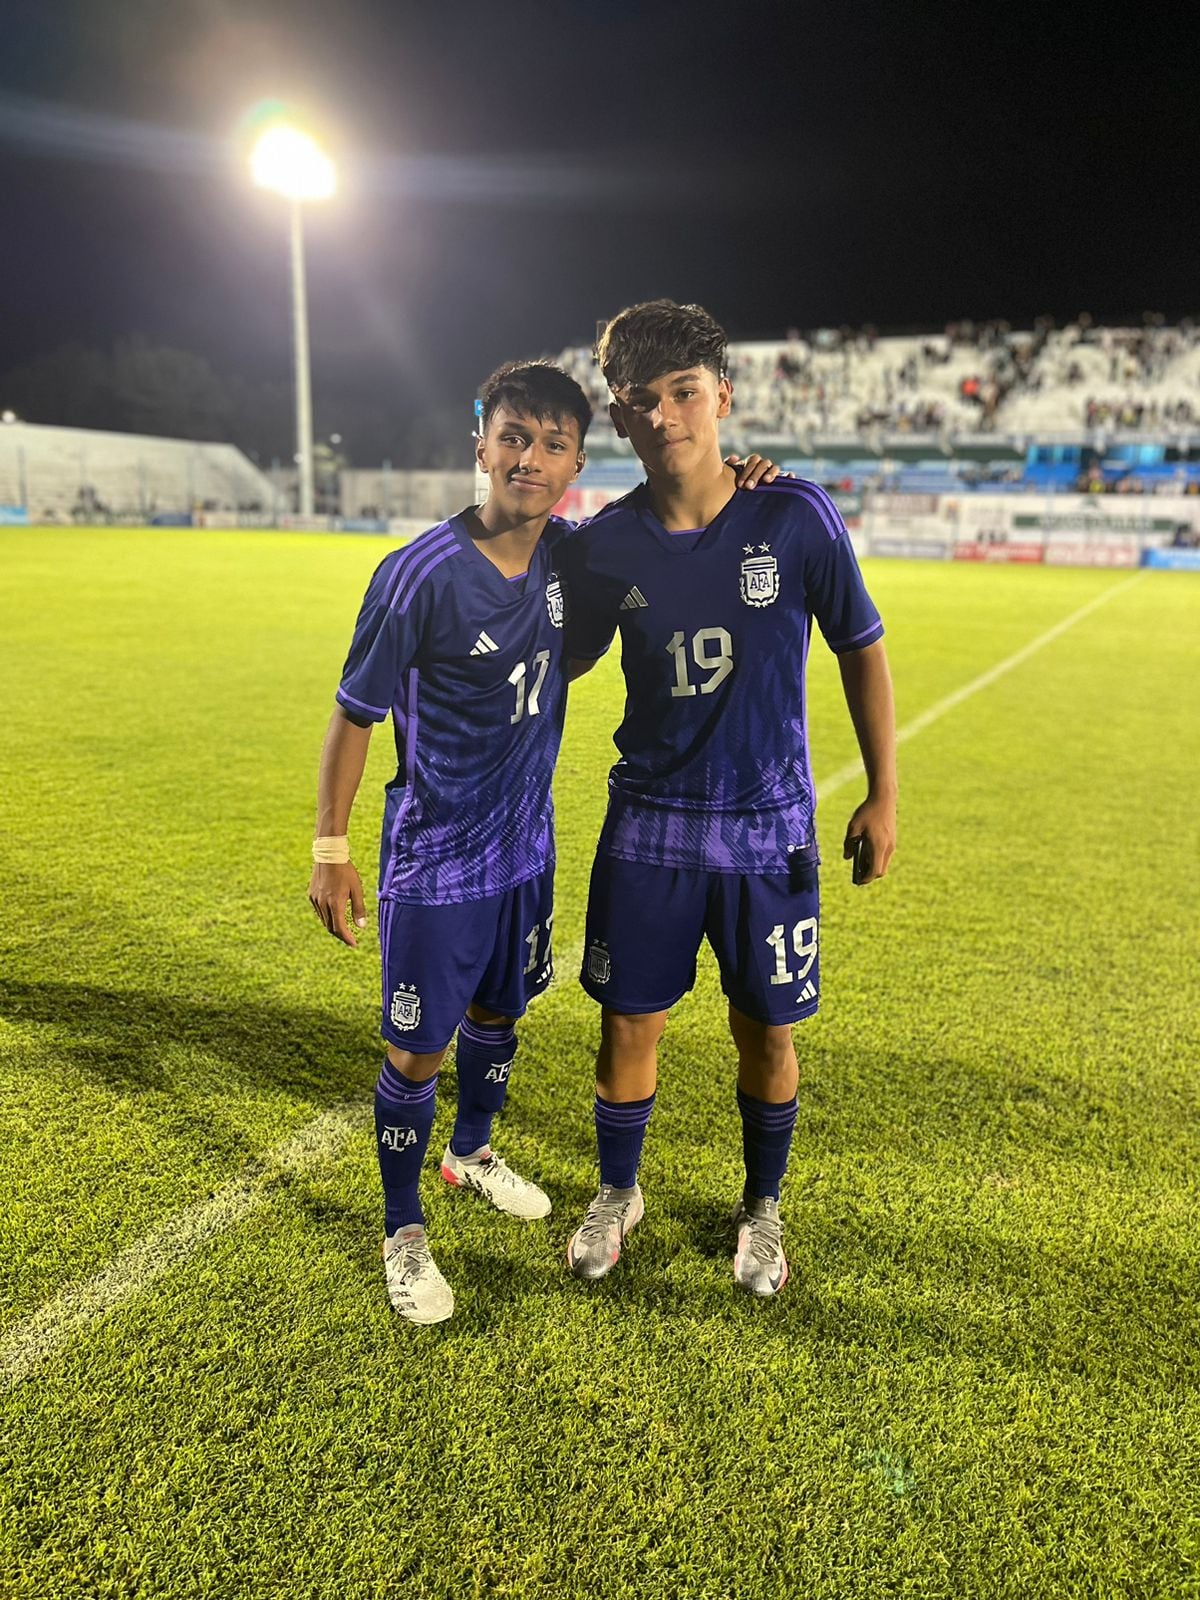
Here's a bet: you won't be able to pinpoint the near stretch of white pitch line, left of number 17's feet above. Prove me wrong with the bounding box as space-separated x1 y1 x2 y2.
0 1106 362 1392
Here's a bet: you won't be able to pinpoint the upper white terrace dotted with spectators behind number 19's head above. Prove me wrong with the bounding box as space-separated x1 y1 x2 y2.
562 315 1200 442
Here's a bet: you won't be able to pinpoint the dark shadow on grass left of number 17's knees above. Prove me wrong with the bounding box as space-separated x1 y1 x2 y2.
0 979 382 1106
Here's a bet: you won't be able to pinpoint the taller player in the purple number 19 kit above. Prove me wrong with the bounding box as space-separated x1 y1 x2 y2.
565 301 896 1294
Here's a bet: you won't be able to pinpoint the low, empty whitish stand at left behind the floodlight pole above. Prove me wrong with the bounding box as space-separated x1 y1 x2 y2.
0 421 275 522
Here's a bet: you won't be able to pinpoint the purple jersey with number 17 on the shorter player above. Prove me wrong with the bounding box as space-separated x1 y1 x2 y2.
338 514 570 906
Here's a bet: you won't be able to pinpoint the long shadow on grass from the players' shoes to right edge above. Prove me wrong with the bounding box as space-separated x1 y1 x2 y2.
265 1152 1200 1376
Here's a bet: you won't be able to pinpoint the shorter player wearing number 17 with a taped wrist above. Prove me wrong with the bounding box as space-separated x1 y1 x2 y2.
309 362 784 1323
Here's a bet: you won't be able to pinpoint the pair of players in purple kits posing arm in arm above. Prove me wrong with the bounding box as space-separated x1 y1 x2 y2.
310 302 896 1322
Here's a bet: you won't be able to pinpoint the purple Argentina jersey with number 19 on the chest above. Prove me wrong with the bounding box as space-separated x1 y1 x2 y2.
565 478 883 874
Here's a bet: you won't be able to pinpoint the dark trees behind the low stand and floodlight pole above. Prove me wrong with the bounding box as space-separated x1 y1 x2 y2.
0 334 470 467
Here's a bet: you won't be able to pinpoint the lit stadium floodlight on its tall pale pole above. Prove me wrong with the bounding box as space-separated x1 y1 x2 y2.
250 122 338 517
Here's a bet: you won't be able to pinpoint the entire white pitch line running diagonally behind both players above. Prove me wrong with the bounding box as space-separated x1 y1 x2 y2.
0 573 1144 1392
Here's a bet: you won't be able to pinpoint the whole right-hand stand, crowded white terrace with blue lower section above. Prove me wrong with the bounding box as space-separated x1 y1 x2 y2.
558 317 1200 570
